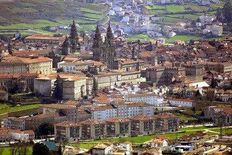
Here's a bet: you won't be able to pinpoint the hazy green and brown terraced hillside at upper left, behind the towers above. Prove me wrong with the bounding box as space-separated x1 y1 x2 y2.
0 0 108 30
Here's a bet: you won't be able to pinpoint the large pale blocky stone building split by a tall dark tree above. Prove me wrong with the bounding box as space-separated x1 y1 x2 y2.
34 74 93 100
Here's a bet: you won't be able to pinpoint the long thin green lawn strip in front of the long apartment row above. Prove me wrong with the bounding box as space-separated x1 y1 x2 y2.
71 126 223 149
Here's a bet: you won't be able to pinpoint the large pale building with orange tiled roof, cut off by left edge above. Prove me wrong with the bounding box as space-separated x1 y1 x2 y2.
0 56 52 74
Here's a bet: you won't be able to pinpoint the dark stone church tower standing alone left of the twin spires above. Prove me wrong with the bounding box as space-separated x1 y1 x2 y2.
69 20 79 53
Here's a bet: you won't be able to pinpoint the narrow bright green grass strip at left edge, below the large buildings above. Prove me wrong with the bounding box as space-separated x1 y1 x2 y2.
0 103 40 114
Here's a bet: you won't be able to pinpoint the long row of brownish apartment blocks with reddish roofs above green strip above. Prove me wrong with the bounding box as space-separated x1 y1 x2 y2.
55 113 179 141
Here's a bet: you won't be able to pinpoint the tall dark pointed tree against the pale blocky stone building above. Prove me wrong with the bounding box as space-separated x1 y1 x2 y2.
53 75 63 100
